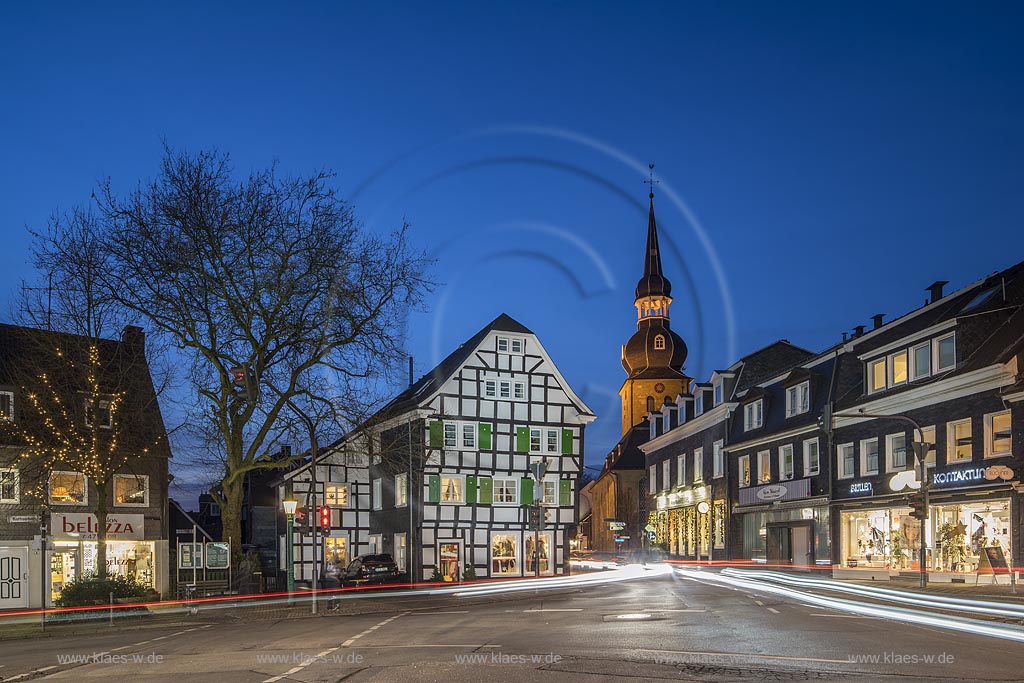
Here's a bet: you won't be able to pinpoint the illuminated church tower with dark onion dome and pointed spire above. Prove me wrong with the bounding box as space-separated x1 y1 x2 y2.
618 184 692 435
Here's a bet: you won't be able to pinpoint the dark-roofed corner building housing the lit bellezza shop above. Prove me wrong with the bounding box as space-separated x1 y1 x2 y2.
0 325 171 610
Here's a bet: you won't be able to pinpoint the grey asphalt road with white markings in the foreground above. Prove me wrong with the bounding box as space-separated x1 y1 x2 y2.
0 569 1024 683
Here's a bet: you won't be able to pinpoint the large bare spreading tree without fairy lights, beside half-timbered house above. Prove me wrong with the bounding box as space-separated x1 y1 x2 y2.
77 148 429 553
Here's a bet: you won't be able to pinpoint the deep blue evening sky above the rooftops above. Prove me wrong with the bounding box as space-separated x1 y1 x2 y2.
0 2 1024 497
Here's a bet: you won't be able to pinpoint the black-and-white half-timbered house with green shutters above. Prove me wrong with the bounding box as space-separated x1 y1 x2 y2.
279 313 595 582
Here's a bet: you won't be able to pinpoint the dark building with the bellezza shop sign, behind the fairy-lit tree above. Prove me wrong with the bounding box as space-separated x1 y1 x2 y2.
0 325 171 610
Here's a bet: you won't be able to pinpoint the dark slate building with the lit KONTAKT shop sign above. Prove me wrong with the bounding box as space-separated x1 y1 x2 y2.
833 264 1024 583
